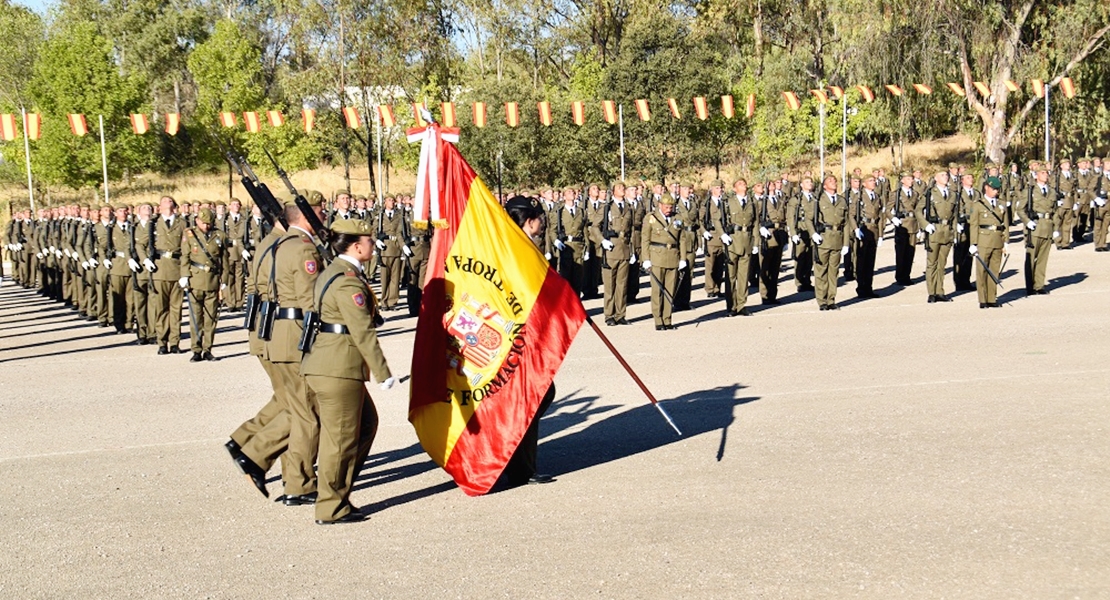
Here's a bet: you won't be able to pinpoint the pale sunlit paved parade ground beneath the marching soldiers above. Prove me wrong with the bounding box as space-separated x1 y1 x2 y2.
0 240 1110 599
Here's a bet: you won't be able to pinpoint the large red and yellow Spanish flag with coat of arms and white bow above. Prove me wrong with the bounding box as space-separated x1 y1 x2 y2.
408 124 586 496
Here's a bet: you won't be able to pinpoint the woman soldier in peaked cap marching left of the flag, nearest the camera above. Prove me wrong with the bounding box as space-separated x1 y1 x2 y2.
301 218 394 525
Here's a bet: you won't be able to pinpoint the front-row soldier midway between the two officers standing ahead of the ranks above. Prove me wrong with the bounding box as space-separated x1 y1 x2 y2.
801 175 848 311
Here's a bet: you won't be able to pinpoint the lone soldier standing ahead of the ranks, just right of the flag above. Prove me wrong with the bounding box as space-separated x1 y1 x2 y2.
640 194 689 332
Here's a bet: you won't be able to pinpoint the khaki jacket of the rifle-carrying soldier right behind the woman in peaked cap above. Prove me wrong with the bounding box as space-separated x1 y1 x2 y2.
267 227 322 363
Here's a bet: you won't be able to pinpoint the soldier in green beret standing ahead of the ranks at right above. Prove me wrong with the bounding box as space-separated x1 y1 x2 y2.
968 176 1010 308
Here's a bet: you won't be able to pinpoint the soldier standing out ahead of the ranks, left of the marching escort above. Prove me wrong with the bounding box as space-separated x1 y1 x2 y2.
178 209 226 363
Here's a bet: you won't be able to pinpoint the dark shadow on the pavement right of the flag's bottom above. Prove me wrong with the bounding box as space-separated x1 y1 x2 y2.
537 384 759 475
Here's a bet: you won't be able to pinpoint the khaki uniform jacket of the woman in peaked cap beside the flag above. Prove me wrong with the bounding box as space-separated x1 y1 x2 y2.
301 258 393 382
